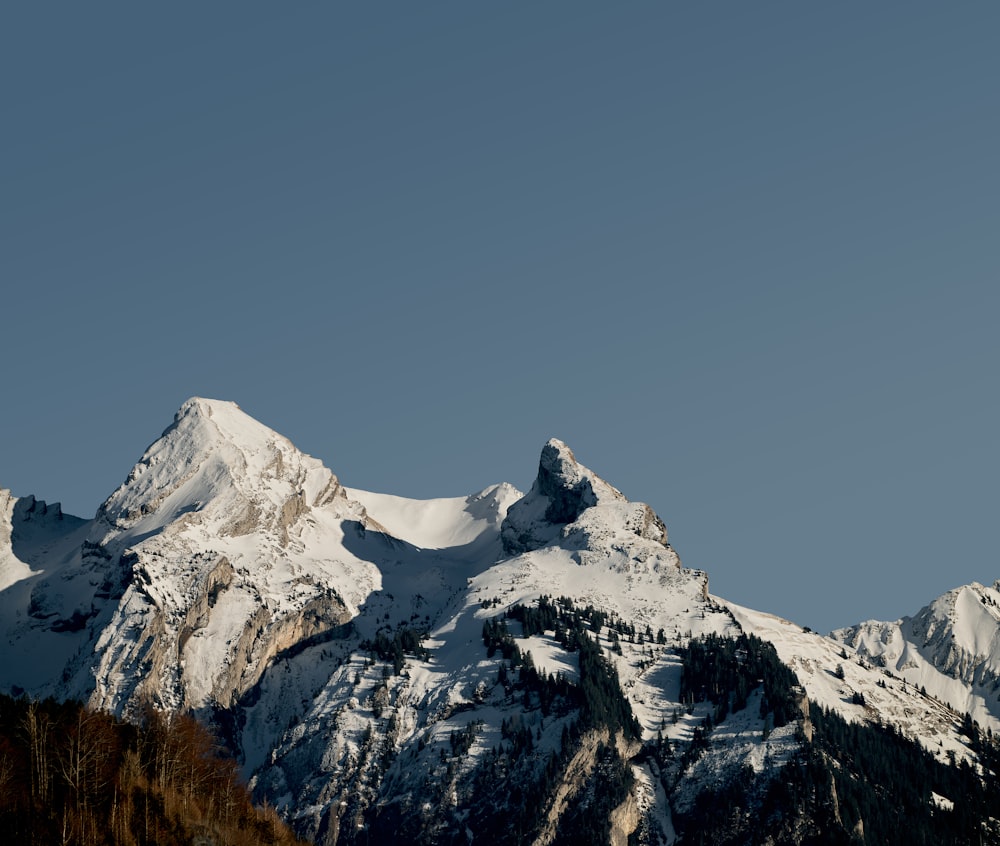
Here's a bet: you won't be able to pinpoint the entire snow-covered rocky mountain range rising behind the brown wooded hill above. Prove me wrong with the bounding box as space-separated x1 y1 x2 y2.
0 399 1000 844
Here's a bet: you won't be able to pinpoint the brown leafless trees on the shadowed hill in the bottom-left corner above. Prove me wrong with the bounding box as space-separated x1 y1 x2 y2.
0 696 297 846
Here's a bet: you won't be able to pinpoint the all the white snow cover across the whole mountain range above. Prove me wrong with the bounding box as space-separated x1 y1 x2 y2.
0 398 1000 840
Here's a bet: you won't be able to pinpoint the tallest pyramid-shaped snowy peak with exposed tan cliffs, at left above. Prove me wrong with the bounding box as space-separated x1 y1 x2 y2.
5 399 380 724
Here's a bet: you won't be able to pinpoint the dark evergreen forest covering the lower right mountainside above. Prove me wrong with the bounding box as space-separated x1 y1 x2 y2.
668 635 1000 846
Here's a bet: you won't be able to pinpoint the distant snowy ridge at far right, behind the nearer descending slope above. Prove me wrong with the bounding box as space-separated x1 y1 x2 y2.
832 582 1000 732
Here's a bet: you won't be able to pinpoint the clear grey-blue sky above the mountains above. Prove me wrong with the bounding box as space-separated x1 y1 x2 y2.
0 2 1000 631
